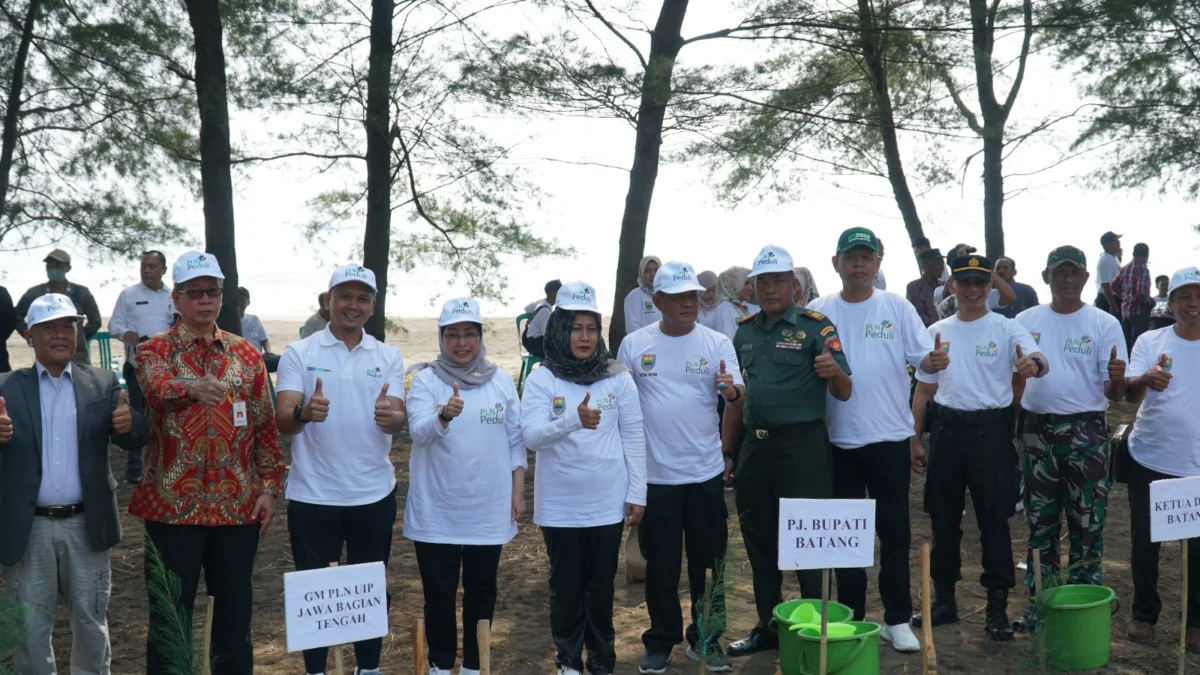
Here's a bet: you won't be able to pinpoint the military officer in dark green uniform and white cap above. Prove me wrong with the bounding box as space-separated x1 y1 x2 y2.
722 246 851 656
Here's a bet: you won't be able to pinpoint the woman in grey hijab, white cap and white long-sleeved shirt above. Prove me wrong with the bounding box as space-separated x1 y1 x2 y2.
404 298 527 675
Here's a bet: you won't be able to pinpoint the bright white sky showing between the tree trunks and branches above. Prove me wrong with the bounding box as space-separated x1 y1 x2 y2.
0 2 1200 318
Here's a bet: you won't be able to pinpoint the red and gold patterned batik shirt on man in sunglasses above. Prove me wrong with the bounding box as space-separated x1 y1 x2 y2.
130 321 283 526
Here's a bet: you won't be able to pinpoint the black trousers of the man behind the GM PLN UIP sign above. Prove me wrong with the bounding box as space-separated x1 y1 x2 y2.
288 489 396 673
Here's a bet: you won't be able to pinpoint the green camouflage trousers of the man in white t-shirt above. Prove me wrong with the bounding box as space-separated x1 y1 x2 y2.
1020 411 1109 587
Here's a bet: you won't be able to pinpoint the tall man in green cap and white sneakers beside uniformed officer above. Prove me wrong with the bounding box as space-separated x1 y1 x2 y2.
809 227 949 652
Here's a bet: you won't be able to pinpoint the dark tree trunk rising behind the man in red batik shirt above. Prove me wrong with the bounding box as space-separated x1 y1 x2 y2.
185 0 241 335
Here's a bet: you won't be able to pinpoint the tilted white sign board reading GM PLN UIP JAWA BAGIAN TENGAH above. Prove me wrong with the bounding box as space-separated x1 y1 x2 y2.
283 562 388 651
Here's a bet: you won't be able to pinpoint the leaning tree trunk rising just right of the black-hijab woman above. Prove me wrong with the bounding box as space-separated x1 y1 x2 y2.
608 0 688 353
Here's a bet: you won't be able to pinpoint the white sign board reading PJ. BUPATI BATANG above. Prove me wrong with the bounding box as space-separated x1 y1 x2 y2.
779 500 875 569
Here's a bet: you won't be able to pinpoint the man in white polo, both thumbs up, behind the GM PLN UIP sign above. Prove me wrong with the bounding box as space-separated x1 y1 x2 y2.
276 264 404 675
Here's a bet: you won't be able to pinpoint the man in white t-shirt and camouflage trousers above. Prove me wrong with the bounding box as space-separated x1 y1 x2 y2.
1015 246 1126 629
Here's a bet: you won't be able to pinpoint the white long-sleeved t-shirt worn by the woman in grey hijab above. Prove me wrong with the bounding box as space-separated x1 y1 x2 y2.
404 368 527 546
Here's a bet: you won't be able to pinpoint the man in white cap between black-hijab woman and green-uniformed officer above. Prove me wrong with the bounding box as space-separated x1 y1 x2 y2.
617 262 744 673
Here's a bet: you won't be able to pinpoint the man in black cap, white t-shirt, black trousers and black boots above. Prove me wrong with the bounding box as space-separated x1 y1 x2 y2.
910 255 1050 640
